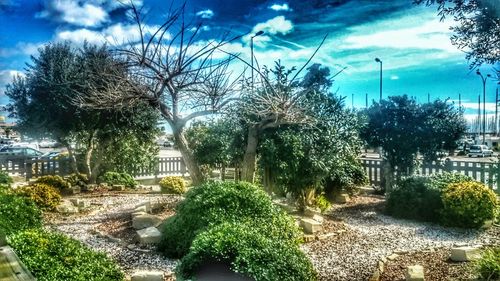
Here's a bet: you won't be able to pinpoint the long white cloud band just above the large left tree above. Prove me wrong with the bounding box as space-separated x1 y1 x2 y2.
55 23 163 45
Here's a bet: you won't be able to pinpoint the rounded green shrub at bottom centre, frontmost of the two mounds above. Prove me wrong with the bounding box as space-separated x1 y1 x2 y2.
177 222 317 281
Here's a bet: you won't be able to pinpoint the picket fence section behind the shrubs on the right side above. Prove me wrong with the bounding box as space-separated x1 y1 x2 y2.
361 158 500 192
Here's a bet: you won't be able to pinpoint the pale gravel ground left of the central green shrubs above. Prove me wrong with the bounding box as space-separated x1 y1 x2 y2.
48 194 181 274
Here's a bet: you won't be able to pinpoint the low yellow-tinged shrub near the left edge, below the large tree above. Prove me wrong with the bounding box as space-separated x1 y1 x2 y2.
16 183 61 210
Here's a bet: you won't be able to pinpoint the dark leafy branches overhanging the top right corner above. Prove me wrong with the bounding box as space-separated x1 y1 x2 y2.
415 0 500 67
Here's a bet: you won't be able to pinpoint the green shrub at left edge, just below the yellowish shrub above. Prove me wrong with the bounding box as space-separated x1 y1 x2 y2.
0 194 42 235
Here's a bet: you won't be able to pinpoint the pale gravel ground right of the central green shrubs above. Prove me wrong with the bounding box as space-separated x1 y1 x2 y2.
302 196 500 280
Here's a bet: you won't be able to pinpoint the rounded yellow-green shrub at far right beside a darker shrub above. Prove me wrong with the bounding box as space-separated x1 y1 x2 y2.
441 181 498 228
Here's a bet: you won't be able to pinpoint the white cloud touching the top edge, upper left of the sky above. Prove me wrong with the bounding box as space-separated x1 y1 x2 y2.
36 0 109 27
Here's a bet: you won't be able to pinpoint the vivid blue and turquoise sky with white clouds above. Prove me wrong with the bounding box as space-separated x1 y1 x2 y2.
0 0 497 117
